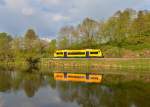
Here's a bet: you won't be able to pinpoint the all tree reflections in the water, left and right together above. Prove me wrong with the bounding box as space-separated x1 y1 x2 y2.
0 69 150 107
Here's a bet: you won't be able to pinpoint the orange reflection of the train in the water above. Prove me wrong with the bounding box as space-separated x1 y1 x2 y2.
54 72 102 83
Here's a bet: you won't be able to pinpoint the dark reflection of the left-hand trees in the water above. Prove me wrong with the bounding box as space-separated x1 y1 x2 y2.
0 69 44 97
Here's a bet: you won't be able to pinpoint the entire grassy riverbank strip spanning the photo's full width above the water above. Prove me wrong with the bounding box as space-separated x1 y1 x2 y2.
0 58 150 72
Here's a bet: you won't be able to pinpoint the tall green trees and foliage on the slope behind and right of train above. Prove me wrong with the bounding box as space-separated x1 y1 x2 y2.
57 9 150 57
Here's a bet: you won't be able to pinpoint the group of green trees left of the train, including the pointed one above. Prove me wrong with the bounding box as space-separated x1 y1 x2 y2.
0 29 48 64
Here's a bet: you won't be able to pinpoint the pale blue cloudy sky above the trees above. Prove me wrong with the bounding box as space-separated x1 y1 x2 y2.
0 0 150 38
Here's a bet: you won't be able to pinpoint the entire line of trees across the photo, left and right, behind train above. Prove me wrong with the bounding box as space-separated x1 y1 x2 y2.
0 9 150 61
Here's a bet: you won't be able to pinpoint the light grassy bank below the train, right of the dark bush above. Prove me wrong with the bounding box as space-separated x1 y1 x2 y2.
41 58 150 71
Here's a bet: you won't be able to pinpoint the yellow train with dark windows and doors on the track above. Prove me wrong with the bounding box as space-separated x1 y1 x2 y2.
54 49 104 58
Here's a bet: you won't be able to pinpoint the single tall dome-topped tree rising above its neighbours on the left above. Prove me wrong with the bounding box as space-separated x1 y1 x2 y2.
23 29 43 66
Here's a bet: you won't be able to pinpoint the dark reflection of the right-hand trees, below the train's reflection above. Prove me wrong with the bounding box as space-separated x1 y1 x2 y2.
53 75 150 107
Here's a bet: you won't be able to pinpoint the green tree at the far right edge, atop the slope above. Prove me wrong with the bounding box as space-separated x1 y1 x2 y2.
131 11 150 44
